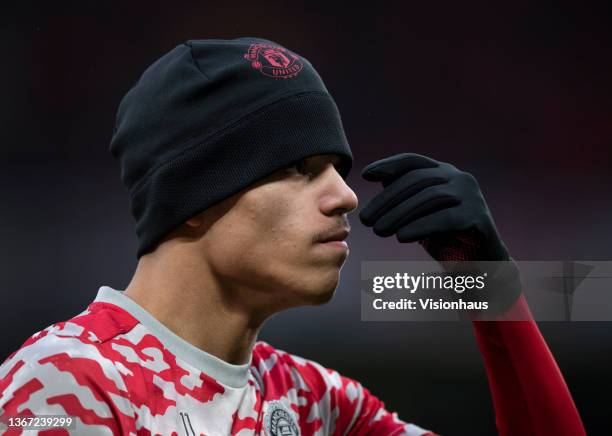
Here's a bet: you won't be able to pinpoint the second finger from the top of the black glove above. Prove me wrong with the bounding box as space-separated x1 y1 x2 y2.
359 167 448 227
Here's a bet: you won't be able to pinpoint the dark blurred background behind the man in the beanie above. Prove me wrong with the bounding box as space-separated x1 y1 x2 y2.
0 0 612 435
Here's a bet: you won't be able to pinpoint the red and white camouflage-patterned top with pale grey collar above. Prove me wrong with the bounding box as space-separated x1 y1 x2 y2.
0 286 433 436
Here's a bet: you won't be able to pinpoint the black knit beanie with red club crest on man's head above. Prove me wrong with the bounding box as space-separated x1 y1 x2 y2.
110 37 353 258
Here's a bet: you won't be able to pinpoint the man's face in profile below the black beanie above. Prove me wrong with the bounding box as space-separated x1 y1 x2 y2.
195 154 357 309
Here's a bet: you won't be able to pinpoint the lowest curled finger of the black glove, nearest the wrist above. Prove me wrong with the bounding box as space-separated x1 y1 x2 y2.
397 205 472 242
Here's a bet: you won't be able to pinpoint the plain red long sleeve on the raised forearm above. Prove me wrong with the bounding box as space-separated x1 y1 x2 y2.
473 295 586 436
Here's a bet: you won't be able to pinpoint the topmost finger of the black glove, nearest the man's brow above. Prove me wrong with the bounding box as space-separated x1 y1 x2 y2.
361 153 440 186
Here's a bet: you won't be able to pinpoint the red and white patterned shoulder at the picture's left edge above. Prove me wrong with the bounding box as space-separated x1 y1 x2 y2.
0 303 137 432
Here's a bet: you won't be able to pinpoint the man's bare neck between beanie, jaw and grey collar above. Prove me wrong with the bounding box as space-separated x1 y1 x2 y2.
124 244 267 365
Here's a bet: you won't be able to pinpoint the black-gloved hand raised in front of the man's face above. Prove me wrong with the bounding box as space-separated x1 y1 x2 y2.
359 153 510 261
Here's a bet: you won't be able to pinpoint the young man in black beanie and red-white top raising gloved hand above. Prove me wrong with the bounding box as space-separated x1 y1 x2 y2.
0 38 584 436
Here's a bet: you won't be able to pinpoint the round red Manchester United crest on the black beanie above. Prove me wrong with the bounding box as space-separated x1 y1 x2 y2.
244 43 304 79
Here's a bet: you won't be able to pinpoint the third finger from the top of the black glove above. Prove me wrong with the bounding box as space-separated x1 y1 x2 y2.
374 185 461 236
